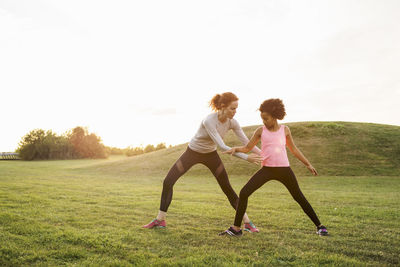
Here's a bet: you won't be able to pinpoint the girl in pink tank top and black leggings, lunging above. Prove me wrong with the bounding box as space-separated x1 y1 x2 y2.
221 99 328 236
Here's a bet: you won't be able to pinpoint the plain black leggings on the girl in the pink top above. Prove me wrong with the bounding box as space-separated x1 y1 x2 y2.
234 166 321 227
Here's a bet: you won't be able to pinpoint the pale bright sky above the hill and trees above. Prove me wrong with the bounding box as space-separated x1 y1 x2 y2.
0 0 400 152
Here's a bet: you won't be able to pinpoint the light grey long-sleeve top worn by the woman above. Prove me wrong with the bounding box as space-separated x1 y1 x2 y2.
189 113 261 160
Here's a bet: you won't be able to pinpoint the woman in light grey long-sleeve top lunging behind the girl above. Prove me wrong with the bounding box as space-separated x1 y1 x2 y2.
143 92 261 232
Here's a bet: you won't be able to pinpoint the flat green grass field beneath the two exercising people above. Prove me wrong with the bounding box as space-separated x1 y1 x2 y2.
0 158 400 266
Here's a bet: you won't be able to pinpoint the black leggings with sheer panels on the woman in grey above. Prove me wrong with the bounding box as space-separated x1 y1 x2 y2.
160 147 239 213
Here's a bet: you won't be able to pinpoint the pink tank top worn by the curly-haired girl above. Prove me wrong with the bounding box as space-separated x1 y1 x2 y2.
261 125 289 167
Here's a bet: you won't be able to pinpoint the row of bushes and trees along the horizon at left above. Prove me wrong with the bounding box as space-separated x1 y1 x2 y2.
16 126 166 160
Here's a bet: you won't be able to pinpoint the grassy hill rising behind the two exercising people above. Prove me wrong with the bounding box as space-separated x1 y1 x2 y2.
81 122 400 176
